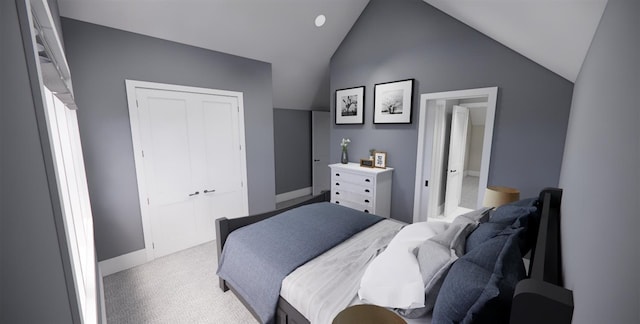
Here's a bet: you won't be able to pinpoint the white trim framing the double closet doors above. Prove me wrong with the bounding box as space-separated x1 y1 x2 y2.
125 80 249 261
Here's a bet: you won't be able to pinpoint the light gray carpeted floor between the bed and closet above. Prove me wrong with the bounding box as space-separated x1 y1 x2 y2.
104 242 257 324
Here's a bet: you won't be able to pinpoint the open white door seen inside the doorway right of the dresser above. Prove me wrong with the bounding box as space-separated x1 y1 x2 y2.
444 106 469 216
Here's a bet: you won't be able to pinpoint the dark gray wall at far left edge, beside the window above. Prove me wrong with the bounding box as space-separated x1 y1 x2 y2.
0 1 72 323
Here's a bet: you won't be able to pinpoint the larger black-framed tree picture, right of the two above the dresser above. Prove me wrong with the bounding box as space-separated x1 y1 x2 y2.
373 79 413 124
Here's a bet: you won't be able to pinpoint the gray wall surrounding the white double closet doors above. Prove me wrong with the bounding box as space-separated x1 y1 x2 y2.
62 18 275 260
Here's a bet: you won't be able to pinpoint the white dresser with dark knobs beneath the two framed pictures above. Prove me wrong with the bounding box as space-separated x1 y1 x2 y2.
329 163 393 218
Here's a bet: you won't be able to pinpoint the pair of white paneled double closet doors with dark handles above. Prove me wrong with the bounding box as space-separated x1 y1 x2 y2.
132 83 247 257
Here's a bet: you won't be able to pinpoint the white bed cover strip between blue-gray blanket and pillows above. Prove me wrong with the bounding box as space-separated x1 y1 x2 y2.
280 220 404 324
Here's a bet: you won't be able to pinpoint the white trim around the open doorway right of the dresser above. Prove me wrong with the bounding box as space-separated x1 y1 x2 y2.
413 87 498 222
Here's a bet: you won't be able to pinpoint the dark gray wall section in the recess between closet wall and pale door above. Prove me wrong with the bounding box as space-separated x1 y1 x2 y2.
273 109 311 194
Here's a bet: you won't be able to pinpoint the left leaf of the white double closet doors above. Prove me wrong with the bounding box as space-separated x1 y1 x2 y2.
137 89 199 257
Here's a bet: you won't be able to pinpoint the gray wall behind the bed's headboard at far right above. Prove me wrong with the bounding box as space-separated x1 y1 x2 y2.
560 0 640 324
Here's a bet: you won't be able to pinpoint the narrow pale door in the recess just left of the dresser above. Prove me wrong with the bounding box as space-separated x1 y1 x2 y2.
311 111 331 195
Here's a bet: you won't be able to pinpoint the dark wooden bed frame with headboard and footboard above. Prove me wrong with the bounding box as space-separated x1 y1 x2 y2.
216 188 573 324
